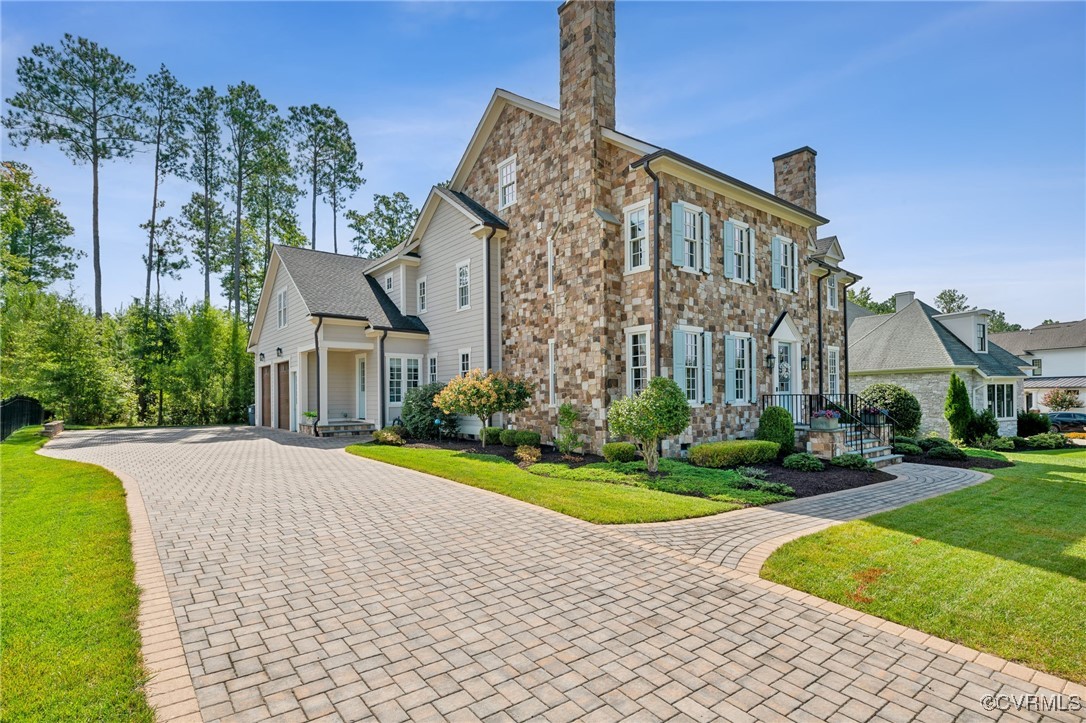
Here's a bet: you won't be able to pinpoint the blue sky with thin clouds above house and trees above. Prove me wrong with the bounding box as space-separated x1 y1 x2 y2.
0 0 1086 325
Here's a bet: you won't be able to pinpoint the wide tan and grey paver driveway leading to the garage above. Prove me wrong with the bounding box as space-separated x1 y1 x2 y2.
40 429 1077 721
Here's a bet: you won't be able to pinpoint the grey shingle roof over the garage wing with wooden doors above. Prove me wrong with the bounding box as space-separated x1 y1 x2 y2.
276 246 428 332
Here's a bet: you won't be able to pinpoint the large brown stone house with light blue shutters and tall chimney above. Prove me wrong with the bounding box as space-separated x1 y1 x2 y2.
249 0 859 454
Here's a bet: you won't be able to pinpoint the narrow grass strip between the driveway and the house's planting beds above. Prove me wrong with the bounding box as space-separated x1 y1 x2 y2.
348 444 742 524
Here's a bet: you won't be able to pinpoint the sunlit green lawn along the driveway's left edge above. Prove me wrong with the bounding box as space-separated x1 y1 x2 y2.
0 428 153 721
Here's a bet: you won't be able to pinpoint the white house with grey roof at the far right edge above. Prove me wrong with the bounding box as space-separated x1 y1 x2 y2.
992 319 1086 411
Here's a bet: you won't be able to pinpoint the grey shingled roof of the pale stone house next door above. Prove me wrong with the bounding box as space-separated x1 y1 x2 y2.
848 300 1025 377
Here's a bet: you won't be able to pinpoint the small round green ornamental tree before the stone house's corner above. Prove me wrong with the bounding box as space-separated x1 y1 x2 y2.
607 377 690 472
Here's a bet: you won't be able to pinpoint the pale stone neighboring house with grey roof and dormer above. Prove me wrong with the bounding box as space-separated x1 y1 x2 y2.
848 291 1025 436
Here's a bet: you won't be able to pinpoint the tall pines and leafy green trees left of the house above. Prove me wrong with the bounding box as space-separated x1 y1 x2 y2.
0 35 417 423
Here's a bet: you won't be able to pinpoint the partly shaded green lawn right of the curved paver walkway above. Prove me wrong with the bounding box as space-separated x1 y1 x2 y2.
761 448 1086 683
